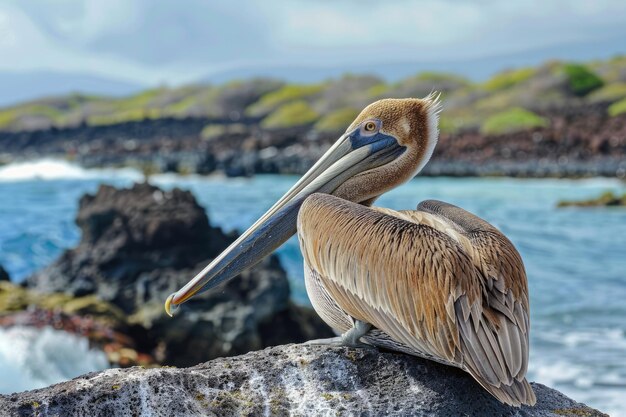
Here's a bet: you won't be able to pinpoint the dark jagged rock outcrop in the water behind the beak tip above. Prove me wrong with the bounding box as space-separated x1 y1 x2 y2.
26 184 332 366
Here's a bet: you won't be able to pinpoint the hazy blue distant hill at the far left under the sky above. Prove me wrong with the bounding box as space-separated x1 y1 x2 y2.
0 71 142 106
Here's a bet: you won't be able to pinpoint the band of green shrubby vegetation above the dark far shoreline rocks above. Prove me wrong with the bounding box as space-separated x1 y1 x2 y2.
0 56 626 135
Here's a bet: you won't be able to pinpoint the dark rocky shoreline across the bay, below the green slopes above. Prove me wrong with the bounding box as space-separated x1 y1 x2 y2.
0 104 626 178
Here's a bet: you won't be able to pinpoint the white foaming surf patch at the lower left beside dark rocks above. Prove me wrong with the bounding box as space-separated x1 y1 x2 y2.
0 326 109 394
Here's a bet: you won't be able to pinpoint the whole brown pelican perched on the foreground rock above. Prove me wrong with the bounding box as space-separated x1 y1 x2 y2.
165 95 536 406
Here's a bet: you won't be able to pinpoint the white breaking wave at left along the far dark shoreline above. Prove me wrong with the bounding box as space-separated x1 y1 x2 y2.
0 159 143 182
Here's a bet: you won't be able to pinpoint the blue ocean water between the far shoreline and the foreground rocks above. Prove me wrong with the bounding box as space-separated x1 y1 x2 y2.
0 161 626 416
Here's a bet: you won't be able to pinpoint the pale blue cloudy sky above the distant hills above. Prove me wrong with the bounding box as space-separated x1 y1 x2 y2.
0 0 626 85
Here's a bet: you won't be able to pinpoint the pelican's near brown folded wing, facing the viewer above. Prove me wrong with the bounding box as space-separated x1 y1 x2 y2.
298 195 535 405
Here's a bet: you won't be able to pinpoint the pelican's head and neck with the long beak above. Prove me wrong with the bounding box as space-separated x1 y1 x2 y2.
165 94 441 315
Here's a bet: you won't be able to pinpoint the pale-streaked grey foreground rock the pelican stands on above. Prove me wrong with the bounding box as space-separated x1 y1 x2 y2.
0 345 606 417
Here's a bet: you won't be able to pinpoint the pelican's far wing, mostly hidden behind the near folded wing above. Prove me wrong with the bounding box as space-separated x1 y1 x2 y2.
417 200 536 403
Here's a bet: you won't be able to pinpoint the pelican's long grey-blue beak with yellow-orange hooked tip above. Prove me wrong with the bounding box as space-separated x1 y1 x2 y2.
165 129 405 316
